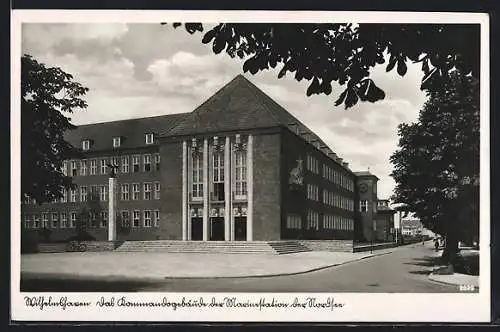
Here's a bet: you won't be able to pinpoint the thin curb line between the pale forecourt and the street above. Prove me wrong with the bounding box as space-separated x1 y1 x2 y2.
21 251 392 282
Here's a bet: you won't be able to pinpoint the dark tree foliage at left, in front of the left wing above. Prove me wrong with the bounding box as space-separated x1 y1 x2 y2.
21 55 88 204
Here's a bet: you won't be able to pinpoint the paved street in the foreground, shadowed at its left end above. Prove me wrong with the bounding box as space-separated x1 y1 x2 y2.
21 242 458 293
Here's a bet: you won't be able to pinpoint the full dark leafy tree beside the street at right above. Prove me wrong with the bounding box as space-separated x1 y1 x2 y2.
391 72 479 262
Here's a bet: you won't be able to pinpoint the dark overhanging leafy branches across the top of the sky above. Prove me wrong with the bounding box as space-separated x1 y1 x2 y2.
170 23 480 109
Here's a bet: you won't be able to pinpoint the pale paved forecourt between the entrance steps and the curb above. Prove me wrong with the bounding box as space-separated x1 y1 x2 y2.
21 250 391 279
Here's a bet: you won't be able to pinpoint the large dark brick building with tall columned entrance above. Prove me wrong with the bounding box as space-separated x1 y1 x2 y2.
22 75 386 245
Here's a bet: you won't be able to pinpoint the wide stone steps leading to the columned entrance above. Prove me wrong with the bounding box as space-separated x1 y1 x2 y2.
115 240 310 255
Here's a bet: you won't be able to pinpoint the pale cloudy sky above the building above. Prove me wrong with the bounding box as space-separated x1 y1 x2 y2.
21 23 426 198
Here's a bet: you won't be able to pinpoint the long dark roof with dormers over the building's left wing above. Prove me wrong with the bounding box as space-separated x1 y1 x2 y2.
65 113 188 151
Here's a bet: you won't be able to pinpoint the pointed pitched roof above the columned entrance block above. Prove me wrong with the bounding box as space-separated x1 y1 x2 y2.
161 74 347 168
